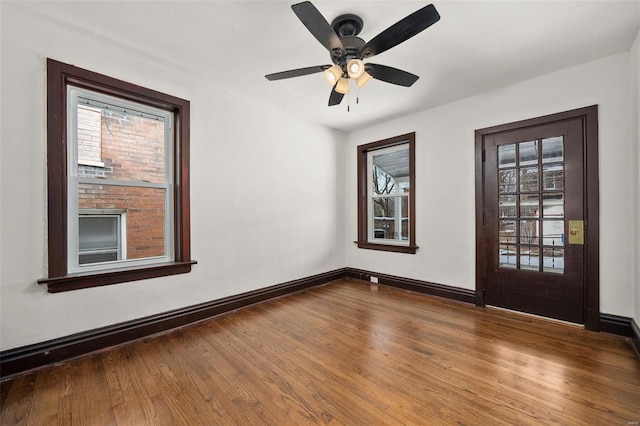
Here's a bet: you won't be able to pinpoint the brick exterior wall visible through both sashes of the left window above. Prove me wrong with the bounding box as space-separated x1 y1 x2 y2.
78 106 165 259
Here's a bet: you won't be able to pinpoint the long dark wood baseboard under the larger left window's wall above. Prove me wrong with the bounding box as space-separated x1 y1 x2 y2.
0 269 346 381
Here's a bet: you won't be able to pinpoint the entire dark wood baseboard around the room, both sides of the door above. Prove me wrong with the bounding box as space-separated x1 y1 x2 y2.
0 268 640 381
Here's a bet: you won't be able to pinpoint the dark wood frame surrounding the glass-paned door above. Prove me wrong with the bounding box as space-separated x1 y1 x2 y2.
475 105 600 331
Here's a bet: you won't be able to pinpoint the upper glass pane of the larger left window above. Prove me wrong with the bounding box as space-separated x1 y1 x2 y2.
77 102 165 183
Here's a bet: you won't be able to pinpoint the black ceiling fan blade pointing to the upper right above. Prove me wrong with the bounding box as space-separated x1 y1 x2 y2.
358 4 440 58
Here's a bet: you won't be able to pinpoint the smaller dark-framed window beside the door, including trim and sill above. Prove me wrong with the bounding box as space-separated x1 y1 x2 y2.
358 133 418 253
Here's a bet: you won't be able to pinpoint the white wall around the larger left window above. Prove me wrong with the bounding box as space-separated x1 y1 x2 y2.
0 3 346 350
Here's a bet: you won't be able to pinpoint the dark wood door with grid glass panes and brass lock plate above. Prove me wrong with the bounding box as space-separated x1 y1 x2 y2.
482 119 585 323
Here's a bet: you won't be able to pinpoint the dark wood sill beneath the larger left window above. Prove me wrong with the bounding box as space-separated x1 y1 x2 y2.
38 260 198 293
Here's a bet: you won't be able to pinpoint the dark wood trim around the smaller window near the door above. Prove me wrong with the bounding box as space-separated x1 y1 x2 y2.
357 132 418 254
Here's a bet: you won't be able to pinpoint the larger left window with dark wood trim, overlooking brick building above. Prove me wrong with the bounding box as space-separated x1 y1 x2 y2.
40 60 195 292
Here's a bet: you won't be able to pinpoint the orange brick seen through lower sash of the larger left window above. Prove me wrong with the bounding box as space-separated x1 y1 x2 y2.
78 183 165 259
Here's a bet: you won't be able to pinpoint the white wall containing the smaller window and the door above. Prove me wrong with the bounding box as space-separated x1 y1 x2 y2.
342 53 637 317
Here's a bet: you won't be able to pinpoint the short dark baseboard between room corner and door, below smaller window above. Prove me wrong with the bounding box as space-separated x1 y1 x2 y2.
347 268 476 303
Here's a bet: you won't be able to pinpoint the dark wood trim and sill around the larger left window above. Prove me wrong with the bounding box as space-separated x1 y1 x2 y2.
38 59 196 292
